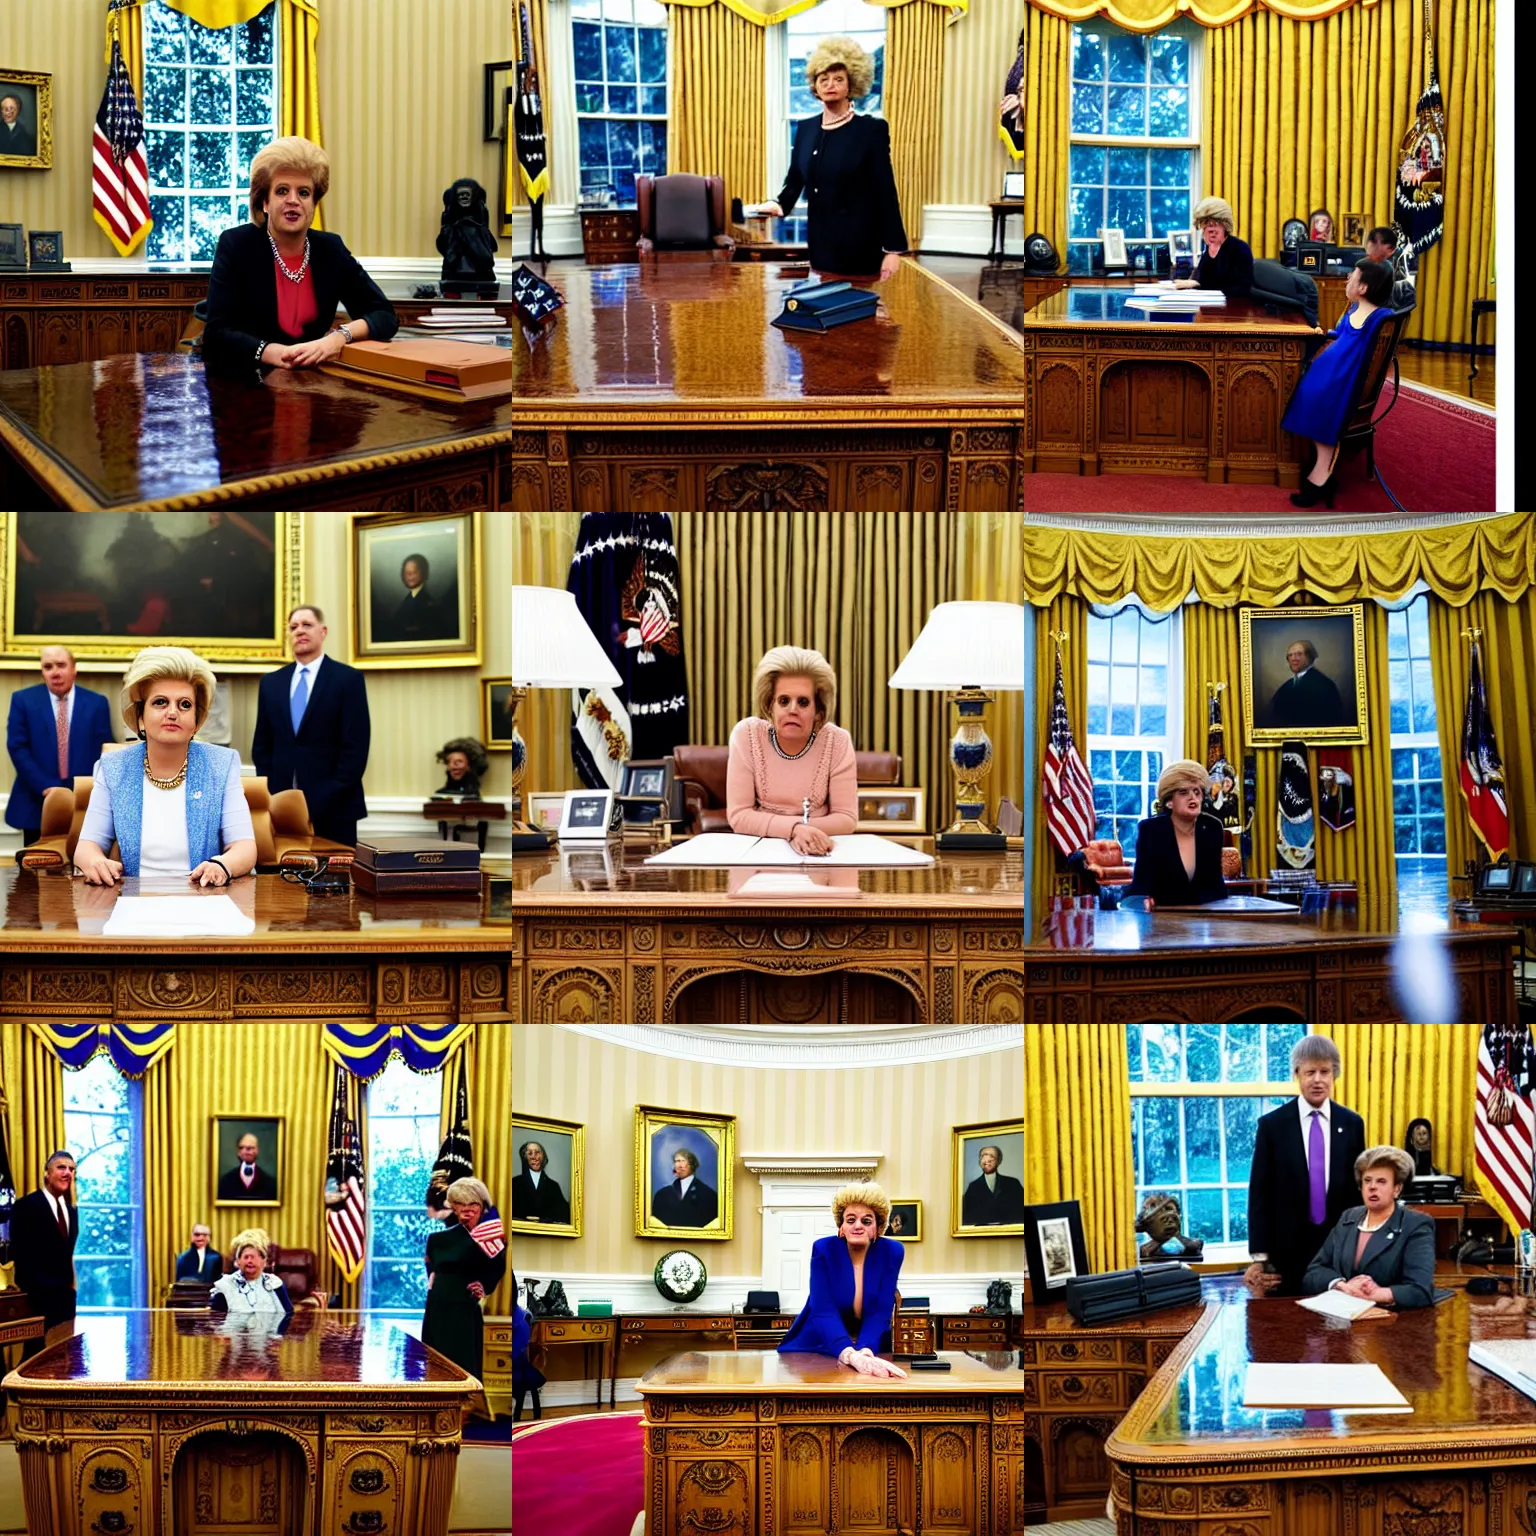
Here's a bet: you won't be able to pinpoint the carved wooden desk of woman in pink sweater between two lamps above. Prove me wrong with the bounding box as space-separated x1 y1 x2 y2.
511 842 1025 1025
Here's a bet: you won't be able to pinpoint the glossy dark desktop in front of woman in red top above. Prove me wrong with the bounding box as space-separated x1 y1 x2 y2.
0 352 511 510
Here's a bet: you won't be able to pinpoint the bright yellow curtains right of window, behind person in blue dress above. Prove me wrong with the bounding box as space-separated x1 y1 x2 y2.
1204 0 1495 343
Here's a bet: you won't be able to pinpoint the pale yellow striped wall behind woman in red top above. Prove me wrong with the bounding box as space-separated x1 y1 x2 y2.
0 0 513 260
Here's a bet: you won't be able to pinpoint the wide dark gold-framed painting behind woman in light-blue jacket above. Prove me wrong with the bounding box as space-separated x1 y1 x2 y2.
0 511 306 673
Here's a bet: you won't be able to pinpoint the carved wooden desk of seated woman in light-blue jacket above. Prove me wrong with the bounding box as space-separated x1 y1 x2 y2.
0 869 510 1021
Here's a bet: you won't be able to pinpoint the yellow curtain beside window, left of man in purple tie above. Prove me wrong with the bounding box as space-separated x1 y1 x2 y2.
1025 1025 1137 1299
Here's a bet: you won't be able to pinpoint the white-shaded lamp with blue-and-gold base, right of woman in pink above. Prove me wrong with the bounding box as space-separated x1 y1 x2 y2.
888 602 1025 851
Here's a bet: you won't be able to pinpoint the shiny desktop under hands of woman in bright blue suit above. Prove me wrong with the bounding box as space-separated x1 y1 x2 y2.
634 1350 1025 1396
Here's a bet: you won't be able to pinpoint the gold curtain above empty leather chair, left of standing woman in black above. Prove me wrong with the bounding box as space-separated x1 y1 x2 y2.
667 5 768 213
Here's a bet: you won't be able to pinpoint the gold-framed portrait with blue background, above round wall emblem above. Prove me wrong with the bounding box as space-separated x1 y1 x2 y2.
634 1104 736 1243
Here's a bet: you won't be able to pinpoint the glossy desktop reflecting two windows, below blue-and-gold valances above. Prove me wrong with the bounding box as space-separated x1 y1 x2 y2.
5 1307 478 1402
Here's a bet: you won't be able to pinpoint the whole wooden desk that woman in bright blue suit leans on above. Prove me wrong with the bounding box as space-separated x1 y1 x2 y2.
637 1350 1026 1536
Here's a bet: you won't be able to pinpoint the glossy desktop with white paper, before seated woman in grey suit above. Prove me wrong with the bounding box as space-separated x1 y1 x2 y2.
1112 1292 1536 1462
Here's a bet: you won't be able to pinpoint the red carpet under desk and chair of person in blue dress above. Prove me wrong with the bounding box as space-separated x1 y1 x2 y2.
1025 384 1496 518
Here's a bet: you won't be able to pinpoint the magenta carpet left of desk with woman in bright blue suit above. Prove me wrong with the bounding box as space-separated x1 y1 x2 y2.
511 1413 645 1536
